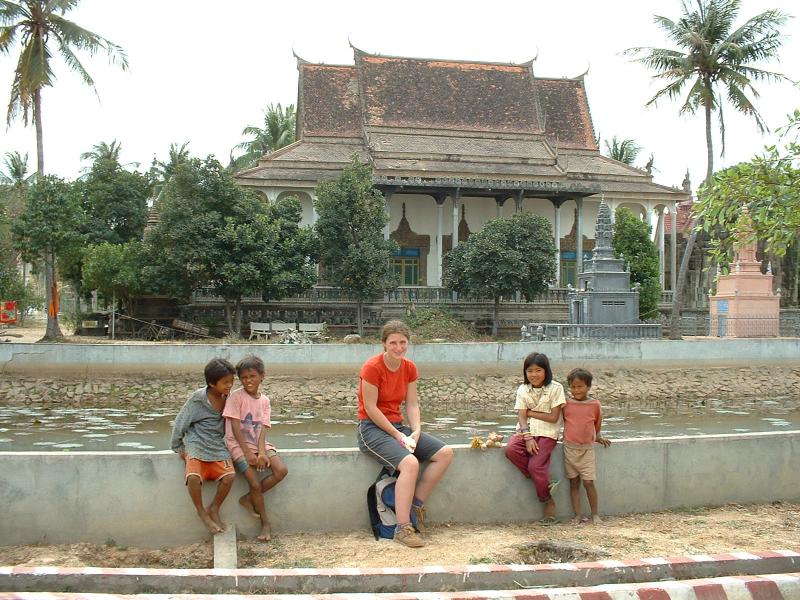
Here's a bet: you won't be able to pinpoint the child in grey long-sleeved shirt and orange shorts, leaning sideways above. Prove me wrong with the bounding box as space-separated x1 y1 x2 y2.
170 358 236 534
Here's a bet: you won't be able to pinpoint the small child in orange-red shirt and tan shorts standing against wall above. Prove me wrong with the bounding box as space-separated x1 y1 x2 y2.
564 369 611 524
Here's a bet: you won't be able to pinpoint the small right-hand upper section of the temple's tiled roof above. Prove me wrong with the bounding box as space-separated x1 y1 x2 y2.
533 77 597 150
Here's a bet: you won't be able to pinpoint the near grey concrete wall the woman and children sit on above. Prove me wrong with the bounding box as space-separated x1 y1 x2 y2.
0 431 800 547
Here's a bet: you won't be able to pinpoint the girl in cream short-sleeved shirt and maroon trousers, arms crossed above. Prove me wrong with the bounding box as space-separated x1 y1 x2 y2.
506 352 566 524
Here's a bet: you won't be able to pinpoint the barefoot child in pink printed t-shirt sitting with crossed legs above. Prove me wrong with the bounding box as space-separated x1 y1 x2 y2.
223 356 289 542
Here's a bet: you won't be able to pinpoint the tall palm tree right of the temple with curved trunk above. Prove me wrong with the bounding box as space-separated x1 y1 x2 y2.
626 0 787 339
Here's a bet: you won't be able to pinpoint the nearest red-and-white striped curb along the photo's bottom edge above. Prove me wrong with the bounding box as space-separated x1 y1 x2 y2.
0 573 800 600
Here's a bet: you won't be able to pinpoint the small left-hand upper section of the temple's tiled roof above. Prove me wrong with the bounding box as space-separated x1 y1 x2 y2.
298 62 361 137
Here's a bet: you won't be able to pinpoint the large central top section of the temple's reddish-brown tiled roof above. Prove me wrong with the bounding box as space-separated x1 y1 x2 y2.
355 50 542 133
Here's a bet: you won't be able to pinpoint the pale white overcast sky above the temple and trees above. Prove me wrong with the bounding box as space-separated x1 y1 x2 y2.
0 0 800 188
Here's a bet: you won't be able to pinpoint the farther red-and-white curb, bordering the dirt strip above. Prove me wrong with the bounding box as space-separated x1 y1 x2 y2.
0 550 800 599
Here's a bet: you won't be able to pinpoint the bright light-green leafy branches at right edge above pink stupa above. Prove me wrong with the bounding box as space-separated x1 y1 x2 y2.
695 109 800 265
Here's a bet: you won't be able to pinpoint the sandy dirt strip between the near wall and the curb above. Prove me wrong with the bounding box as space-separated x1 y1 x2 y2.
0 502 800 568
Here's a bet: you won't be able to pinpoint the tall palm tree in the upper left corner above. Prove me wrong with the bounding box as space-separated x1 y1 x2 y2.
0 0 128 175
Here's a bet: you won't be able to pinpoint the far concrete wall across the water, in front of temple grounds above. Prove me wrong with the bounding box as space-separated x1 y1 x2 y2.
0 338 800 376
